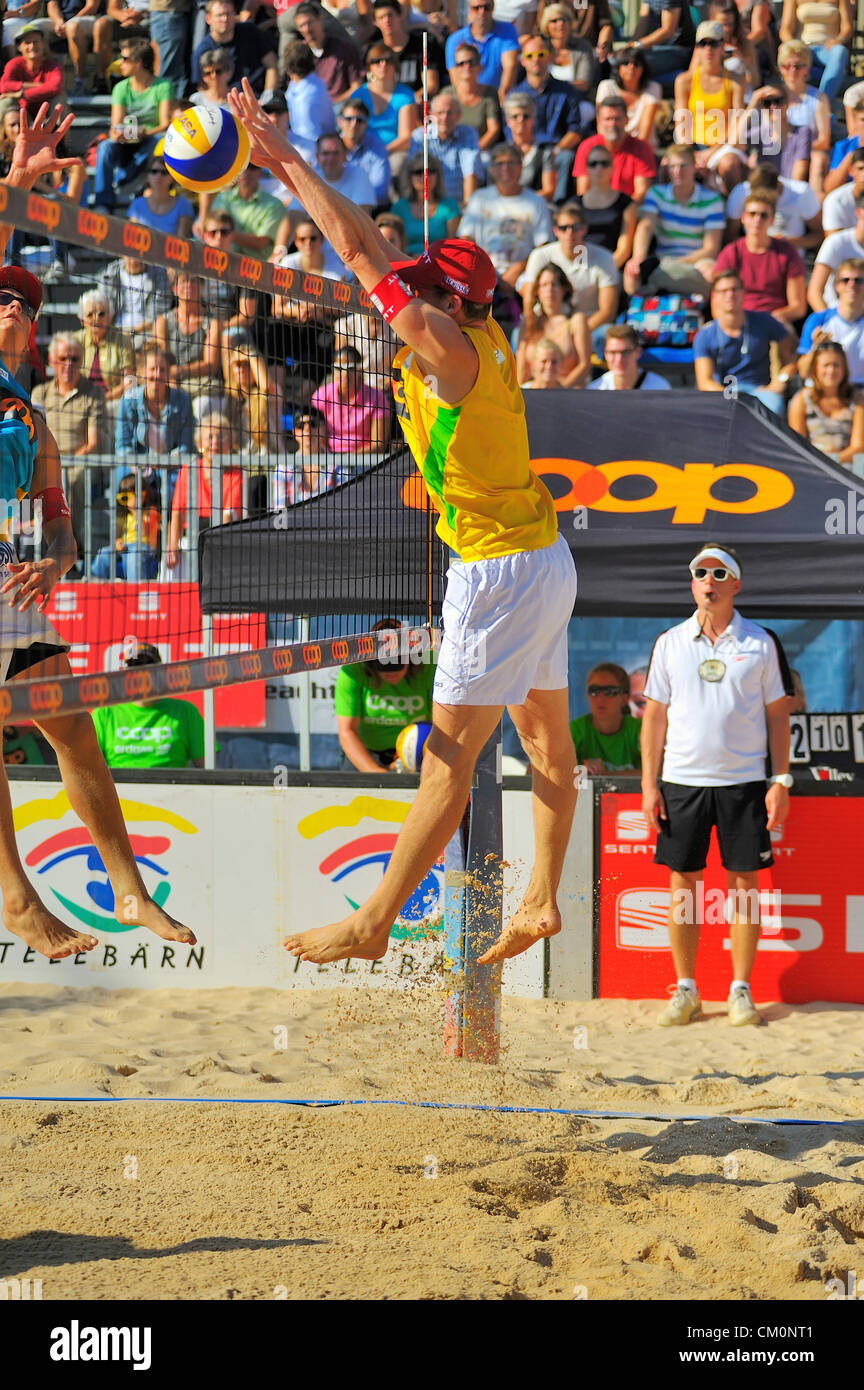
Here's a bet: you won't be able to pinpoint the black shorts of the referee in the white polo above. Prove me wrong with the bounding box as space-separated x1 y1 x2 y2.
654 781 774 873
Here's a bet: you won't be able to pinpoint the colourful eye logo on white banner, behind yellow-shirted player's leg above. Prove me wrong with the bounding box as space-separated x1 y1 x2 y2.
297 796 445 941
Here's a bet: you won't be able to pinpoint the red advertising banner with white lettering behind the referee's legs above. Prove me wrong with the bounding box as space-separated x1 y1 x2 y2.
599 794 864 1004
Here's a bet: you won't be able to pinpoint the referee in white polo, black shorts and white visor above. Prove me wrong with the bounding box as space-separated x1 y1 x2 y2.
642 542 792 1027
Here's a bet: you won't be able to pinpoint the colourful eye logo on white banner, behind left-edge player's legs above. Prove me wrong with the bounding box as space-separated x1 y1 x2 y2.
14 791 199 933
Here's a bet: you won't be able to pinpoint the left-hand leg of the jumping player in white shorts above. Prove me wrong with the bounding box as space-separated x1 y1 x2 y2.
285 705 504 963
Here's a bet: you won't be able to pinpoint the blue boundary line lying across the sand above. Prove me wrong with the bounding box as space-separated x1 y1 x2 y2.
0 1095 864 1129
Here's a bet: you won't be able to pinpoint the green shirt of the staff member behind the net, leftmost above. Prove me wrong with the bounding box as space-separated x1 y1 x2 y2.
93 699 204 767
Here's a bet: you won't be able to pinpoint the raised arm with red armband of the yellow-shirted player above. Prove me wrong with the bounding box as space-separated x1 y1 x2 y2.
228 79 478 403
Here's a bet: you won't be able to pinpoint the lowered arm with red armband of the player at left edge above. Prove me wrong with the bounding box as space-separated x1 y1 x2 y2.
0 413 78 613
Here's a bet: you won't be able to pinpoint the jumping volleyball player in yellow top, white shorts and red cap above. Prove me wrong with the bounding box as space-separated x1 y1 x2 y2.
229 82 576 962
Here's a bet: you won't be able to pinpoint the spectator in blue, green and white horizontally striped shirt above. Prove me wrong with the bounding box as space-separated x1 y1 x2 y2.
624 145 725 295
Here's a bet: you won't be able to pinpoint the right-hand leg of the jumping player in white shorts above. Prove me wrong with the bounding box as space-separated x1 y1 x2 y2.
479 688 576 965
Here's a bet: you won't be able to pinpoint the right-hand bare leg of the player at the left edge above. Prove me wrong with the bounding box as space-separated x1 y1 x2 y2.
14 656 196 945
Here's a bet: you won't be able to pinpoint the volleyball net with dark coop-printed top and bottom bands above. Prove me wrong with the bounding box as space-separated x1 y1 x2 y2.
0 185 446 706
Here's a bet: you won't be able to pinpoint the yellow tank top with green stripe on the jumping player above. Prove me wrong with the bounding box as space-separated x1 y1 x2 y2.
393 318 558 560
